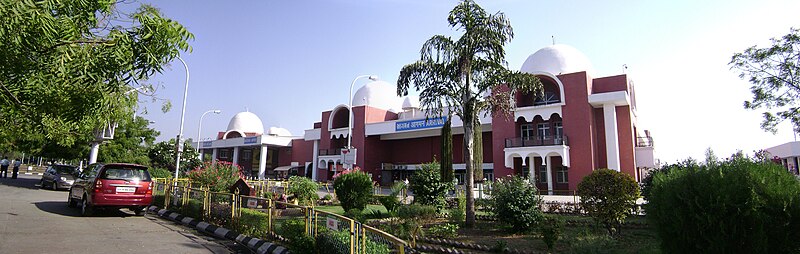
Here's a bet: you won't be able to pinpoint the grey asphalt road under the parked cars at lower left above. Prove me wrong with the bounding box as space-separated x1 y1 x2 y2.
0 174 232 254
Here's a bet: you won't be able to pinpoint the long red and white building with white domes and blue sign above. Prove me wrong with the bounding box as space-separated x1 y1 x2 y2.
200 45 655 191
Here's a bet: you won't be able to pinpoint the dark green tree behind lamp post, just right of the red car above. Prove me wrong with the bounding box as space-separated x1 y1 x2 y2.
147 138 202 172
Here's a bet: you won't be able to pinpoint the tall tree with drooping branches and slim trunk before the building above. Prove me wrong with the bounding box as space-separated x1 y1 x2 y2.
397 0 542 227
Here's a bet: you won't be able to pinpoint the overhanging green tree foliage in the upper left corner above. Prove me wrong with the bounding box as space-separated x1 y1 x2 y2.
0 0 194 147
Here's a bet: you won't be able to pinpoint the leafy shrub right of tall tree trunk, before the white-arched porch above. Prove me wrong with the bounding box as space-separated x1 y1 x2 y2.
491 176 544 232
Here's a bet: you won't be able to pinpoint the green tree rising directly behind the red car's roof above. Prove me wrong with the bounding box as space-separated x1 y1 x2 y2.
97 117 160 165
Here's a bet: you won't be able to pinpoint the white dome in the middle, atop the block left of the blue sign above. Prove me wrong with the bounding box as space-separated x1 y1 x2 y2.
352 80 399 110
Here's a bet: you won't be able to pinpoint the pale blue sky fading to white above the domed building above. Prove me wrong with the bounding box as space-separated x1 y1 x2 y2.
133 0 800 165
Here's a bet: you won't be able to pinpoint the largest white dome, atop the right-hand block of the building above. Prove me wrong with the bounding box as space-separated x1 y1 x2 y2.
520 44 594 75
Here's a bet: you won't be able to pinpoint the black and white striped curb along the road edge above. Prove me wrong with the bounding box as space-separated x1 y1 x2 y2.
148 206 289 254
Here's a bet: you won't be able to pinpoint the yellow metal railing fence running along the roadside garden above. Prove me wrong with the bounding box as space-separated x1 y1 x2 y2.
153 179 408 254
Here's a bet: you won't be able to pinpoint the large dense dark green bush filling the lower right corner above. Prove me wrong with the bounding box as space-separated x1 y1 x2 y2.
646 159 800 253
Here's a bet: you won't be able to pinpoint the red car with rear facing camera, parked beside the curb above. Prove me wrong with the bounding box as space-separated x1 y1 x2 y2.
67 163 153 216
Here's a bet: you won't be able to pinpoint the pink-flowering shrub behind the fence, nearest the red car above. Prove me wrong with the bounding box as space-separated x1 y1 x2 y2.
187 161 244 193
